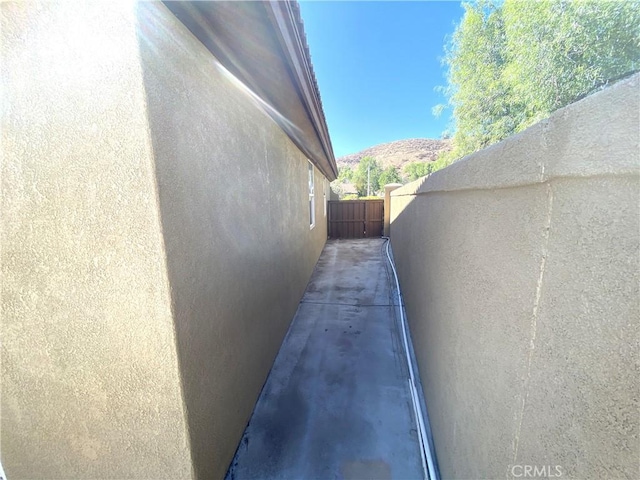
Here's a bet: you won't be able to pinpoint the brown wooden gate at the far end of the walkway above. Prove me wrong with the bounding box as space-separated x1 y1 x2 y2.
328 200 384 238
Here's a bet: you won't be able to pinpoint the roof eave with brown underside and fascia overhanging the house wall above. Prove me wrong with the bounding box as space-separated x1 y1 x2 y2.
164 1 338 180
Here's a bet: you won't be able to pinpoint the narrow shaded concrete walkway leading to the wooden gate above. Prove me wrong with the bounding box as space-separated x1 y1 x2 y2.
227 238 423 480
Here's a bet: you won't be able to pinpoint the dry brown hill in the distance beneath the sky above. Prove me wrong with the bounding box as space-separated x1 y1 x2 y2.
336 138 451 172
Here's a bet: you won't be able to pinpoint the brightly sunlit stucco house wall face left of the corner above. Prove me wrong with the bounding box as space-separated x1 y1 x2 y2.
0 2 191 479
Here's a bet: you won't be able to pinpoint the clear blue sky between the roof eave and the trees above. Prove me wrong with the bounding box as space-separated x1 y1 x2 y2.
300 0 464 157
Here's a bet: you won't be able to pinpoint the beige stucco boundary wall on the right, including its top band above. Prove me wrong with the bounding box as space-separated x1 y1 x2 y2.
391 75 640 479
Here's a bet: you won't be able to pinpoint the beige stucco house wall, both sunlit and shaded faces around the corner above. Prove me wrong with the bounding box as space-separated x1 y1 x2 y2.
0 2 326 480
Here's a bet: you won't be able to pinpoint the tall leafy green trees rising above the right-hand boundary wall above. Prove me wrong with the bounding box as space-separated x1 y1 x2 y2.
434 0 640 169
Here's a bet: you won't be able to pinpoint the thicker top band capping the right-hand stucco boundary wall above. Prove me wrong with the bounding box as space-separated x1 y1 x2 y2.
391 74 640 196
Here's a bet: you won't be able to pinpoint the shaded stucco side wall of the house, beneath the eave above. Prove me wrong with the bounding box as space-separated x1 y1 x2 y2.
138 3 326 478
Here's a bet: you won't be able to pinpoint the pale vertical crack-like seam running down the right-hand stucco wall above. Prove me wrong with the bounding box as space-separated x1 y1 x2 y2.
507 180 553 472
